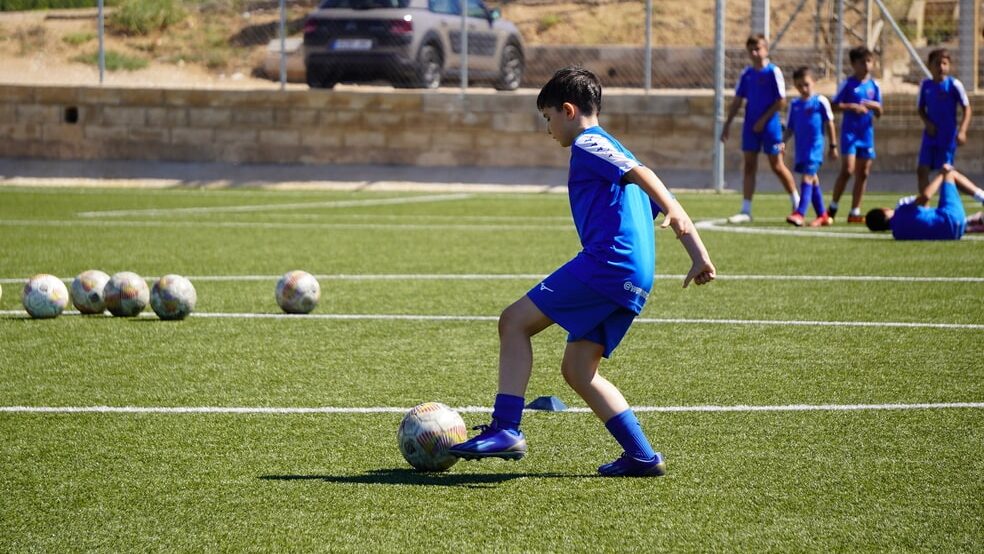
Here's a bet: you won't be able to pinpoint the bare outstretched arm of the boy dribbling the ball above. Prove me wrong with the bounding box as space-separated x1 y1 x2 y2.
625 165 717 288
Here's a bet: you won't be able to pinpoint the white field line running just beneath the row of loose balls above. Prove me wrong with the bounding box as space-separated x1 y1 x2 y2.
0 310 984 330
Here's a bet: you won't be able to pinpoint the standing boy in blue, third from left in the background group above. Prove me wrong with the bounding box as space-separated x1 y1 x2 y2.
827 46 882 223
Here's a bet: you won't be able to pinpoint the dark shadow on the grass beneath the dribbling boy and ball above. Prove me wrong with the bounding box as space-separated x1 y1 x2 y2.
260 468 584 488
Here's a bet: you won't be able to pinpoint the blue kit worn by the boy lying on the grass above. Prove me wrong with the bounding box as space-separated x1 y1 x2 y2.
888 182 967 240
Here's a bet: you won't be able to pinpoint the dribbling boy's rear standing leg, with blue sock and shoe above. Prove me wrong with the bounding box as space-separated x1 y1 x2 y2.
561 340 666 476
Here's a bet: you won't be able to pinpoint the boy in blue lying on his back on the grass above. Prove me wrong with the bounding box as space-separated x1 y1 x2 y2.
865 164 984 240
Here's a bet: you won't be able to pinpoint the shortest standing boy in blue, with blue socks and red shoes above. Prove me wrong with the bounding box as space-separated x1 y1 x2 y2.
782 66 837 227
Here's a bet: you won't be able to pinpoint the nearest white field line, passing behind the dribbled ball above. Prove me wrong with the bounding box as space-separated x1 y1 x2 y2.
0 402 984 415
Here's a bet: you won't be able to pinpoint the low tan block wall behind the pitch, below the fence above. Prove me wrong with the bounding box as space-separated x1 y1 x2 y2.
0 85 984 173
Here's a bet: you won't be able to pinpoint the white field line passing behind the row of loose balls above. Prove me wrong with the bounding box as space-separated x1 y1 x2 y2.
0 273 984 285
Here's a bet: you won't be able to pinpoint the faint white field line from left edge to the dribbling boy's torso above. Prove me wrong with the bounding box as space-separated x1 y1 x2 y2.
0 219 574 232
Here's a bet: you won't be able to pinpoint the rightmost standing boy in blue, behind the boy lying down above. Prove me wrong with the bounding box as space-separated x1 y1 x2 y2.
917 48 971 191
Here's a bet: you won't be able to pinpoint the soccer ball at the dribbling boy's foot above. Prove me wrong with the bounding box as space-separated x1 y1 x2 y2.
396 402 468 471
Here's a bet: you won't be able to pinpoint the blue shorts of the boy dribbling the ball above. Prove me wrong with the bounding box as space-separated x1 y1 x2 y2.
526 268 636 358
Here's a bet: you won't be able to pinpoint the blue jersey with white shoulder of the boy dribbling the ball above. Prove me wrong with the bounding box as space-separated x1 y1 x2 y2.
565 127 659 313
